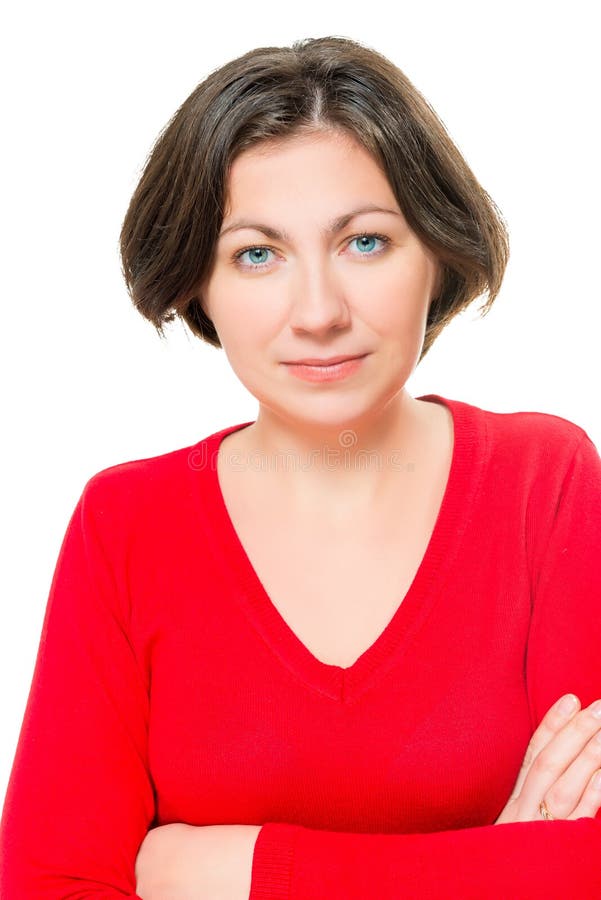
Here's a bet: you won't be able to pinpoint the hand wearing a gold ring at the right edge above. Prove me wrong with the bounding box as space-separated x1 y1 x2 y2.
495 694 601 825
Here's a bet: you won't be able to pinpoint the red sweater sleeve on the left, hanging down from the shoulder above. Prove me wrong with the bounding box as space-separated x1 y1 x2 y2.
0 479 155 900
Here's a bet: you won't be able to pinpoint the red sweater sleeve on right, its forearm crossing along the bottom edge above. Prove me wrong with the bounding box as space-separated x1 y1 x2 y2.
250 433 601 900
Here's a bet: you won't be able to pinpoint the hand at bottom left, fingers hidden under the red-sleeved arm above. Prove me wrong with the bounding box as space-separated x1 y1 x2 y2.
135 822 261 900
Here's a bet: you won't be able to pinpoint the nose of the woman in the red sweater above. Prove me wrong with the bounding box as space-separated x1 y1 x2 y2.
290 262 350 334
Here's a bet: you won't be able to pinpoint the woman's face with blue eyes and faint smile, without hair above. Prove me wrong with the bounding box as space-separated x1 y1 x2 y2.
201 127 439 427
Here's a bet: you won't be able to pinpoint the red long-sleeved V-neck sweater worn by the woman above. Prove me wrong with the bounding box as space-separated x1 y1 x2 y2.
0 394 601 900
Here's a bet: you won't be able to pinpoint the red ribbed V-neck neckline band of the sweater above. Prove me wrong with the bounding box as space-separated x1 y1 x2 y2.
194 394 487 704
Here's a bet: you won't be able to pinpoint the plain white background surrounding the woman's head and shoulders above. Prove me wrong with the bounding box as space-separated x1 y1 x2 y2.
0 0 601 799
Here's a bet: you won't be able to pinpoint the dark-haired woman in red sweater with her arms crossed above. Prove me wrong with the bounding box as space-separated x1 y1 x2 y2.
1 31 601 900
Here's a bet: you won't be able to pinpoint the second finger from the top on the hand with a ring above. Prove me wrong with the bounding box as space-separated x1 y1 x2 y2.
520 700 601 814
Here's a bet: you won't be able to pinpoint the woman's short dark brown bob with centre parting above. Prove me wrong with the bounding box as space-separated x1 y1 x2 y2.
120 37 509 362
